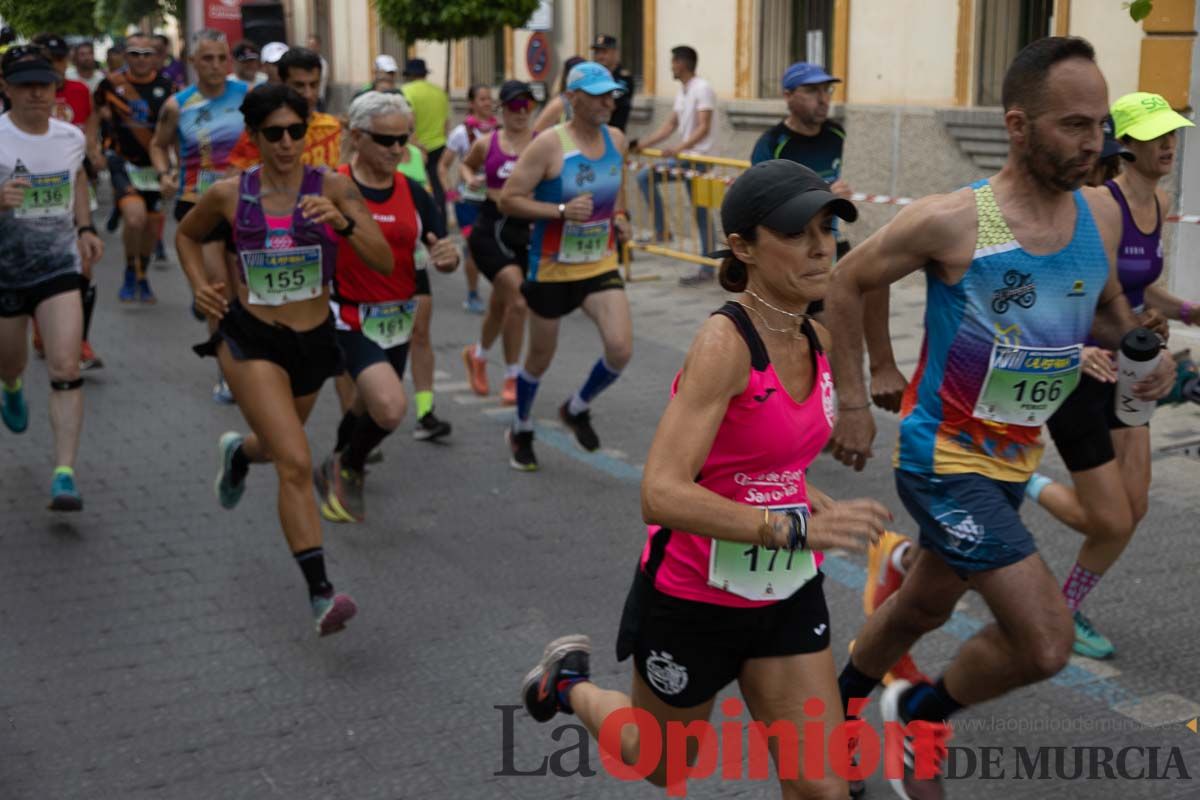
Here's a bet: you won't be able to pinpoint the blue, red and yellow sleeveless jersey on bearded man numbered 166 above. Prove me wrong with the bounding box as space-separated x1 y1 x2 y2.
895 180 1109 482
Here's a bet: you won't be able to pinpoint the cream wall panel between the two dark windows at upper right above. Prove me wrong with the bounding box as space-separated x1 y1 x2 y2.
847 0 959 106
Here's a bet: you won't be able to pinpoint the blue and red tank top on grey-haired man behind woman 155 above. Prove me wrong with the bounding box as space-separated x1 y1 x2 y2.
175 78 248 203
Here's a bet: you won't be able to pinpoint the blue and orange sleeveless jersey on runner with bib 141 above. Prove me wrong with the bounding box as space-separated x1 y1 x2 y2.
528 125 624 283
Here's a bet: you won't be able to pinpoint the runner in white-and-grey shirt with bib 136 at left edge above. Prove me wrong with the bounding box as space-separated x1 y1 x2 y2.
0 44 104 511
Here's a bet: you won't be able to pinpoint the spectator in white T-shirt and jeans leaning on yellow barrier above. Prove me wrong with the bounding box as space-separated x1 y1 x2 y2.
630 44 716 283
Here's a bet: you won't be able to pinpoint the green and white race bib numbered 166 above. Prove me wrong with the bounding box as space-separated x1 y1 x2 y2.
974 343 1084 427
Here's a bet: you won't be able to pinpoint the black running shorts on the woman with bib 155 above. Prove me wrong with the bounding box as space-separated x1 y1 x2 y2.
192 300 342 397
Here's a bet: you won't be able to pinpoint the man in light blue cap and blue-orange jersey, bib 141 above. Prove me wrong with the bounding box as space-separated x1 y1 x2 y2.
498 61 634 471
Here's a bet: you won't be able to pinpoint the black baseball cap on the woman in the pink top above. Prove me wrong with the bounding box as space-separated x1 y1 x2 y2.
709 158 858 258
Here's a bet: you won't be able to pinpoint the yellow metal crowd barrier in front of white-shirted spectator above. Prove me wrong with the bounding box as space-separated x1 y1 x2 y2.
622 148 750 281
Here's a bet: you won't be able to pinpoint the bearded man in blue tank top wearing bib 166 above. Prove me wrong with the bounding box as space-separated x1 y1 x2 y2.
828 37 1174 798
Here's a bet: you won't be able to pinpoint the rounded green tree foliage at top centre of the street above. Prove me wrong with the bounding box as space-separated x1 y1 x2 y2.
374 0 538 42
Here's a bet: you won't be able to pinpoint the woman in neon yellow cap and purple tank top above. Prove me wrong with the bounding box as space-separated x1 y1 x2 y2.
1026 92 1200 658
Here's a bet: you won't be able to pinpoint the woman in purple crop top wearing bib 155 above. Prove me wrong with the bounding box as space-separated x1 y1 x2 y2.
175 84 392 636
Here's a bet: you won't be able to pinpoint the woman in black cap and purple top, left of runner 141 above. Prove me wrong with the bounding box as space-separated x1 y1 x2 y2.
461 80 536 405
